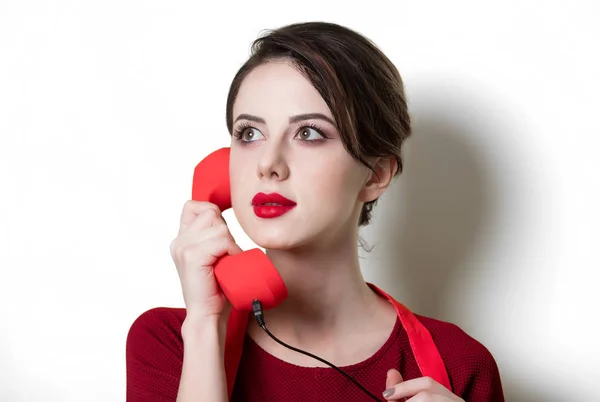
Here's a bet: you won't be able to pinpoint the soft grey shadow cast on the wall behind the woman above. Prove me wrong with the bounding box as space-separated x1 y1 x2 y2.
365 91 557 402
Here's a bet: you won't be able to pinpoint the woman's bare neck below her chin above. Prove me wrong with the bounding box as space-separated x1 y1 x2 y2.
248 234 393 346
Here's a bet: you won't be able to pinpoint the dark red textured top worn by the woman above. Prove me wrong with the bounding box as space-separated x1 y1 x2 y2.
126 308 504 402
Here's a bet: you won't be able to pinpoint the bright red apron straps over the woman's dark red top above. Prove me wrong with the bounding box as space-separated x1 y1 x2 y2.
220 283 452 398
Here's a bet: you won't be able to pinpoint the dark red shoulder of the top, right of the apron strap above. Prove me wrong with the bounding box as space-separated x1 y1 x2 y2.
415 314 504 401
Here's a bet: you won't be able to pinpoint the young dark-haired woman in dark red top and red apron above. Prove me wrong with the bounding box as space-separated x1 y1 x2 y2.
127 22 504 402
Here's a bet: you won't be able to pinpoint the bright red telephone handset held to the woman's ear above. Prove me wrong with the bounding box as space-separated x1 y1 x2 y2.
192 148 287 312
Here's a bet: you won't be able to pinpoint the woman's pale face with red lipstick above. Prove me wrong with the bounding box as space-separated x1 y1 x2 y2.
230 61 379 249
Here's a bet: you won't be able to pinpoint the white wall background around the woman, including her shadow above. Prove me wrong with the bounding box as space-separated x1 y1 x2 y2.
0 0 600 402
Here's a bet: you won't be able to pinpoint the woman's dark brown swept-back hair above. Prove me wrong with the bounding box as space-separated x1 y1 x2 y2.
226 22 411 226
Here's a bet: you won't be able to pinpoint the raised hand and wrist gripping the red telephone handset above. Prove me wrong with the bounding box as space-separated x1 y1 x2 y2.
170 201 242 319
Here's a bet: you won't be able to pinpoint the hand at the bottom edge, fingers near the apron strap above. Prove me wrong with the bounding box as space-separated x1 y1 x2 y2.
383 369 464 402
